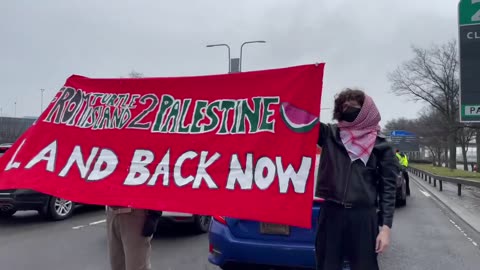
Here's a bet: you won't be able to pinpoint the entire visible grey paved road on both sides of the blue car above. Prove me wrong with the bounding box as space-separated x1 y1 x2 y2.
0 183 480 270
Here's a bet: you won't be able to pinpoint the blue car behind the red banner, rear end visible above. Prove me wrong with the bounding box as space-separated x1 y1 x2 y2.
208 196 323 270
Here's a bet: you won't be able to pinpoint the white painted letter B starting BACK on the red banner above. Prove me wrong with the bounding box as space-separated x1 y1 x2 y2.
124 150 154 186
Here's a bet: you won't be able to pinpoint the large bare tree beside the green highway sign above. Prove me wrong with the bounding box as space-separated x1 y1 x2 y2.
388 41 460 169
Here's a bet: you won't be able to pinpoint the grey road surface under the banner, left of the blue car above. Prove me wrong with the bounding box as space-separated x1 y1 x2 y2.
0 209 216 270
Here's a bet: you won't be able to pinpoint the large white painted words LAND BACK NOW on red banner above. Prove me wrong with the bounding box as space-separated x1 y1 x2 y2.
5 138 314 194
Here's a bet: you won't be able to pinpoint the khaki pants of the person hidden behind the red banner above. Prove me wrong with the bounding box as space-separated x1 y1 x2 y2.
107 207 152 270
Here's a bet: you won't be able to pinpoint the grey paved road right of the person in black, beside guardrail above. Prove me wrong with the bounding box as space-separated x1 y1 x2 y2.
381 177 480 270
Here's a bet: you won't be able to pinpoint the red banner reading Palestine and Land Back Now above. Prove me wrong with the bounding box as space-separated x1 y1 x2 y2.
0 64 324 227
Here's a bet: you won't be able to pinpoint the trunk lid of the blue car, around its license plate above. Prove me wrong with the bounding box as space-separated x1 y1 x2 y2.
225 200 321 243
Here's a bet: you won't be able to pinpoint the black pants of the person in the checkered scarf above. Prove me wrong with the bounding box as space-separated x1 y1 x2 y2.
315 202 379 270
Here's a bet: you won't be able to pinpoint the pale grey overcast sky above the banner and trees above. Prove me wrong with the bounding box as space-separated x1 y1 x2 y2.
0 0 458 124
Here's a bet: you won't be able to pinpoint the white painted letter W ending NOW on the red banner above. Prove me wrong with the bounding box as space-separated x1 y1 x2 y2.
276 157 312 193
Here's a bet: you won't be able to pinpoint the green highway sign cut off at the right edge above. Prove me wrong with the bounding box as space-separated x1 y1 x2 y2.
458 0 480 123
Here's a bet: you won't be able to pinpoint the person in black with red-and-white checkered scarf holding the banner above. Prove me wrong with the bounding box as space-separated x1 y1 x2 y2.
315 89 399 270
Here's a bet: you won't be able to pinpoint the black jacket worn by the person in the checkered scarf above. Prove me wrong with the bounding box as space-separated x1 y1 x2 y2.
315 123 400 228
